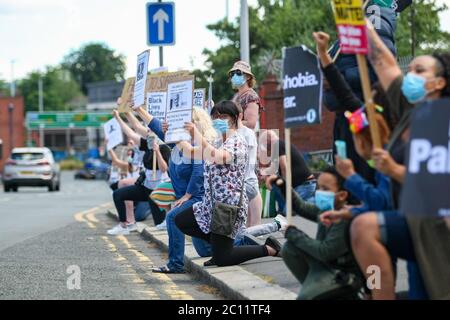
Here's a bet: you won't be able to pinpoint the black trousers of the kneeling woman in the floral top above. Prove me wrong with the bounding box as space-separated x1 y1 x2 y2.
175 207 269 267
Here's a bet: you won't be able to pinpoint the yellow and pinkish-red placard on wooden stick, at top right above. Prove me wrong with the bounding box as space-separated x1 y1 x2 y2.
332 0 368 54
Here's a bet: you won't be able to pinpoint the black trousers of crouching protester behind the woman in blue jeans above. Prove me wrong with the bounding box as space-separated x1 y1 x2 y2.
113 185 166 225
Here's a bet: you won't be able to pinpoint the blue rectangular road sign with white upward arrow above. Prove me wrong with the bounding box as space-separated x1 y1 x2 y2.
147 2 175 46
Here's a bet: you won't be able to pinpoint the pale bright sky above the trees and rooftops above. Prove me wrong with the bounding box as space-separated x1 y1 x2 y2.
0 0 450 81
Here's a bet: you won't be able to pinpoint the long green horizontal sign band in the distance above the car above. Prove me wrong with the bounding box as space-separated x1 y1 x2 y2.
25 112 112 129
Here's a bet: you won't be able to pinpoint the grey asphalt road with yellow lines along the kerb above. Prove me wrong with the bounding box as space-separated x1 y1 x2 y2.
0 172 223 300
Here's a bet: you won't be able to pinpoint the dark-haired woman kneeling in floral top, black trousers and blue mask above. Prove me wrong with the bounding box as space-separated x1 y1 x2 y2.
175 101 280 266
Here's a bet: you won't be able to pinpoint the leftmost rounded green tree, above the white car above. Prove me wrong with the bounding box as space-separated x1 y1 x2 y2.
19 67 85 111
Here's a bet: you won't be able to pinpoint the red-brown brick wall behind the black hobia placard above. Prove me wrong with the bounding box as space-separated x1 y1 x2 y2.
260 75 334 152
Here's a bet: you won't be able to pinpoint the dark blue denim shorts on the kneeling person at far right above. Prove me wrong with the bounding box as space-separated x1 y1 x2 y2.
377 211 416 261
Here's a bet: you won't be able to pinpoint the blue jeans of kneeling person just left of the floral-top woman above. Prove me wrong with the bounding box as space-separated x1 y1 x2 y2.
166 199 200 271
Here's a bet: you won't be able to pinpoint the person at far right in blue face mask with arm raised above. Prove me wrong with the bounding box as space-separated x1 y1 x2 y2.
351 22 450 299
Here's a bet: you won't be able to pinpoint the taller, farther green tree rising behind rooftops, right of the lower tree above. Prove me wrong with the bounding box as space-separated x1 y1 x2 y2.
62 43 126 94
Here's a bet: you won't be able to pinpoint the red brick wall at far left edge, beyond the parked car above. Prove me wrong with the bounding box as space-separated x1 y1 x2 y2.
0 97 25 172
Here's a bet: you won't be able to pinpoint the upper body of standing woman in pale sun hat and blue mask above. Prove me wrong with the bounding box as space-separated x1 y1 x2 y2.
228 61 263 129
